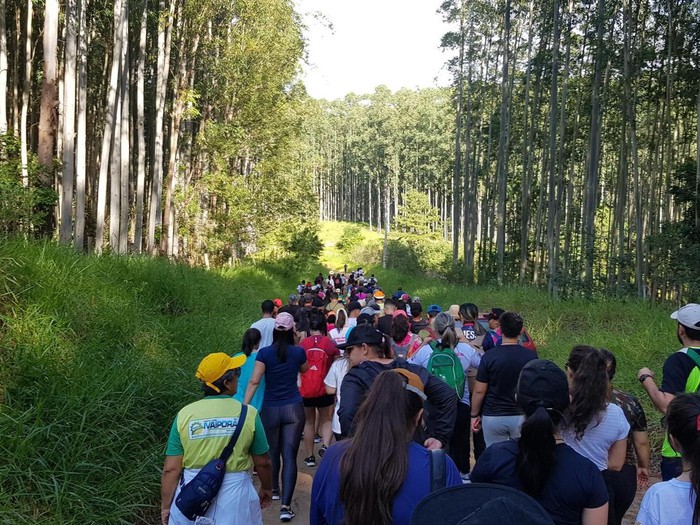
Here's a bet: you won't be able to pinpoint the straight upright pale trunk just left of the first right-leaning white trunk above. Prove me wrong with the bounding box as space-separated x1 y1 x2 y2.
75 0 88 250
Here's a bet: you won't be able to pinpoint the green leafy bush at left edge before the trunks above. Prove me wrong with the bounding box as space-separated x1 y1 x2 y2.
0 133 56 235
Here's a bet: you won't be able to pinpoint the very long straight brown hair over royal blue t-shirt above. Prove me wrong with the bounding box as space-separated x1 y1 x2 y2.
340 371 423 525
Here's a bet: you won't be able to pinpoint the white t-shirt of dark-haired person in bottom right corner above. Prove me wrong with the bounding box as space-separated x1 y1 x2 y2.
635 479 695 525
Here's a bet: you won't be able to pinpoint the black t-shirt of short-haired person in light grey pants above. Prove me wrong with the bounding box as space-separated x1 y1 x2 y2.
476 345 537 416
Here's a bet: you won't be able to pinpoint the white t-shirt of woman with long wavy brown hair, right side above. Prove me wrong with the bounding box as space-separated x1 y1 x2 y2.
561 403 630 470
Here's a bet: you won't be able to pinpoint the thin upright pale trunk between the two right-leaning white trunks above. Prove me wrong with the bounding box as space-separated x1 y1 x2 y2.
134 0 148 253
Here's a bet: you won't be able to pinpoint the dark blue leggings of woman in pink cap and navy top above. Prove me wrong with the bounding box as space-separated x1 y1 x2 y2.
260 402 306 505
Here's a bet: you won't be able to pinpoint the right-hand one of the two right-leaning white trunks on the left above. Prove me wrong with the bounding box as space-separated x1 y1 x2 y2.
146 0 176 253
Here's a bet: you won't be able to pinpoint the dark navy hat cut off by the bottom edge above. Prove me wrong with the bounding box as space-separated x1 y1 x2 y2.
410 483 554 525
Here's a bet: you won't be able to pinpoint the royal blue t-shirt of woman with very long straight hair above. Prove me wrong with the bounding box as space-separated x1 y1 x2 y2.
310 440 462 525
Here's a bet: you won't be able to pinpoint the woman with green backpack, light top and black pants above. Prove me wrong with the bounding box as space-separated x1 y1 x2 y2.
409 312 481 480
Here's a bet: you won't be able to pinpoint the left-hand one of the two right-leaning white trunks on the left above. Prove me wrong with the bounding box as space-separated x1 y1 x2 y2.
95 0 126 253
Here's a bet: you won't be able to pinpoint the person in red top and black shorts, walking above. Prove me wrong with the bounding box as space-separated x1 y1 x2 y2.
299 312 340 467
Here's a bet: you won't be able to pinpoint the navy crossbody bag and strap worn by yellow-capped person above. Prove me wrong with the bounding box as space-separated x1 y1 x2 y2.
175 405 248 520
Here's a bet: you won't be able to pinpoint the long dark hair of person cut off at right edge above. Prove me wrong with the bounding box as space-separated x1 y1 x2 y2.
666 394 700 525
